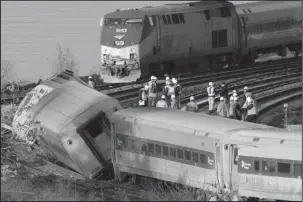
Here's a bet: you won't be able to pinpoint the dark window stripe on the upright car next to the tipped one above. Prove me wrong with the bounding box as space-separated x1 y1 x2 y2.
116 133 215 170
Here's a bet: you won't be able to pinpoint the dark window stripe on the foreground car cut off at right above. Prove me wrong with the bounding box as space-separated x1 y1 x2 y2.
238 156 302 179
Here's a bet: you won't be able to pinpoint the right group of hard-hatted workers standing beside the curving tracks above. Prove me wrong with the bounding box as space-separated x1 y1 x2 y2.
214 82 258 122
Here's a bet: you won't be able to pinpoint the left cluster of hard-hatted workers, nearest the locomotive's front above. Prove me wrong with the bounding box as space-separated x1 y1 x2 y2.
139 76 189 109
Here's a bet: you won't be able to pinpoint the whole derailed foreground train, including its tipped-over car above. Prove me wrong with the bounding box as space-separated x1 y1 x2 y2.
12 72 302 200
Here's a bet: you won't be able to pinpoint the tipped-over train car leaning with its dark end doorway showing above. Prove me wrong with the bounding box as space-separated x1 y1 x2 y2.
13 72 121 178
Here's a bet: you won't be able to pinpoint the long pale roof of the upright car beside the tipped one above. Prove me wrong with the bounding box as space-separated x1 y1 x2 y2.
114 107 284 137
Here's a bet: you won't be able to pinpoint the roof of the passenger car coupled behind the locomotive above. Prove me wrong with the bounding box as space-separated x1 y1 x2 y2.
235 1 302 23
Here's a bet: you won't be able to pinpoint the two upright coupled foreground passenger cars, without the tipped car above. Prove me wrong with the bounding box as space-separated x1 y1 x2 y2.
112 108 302 200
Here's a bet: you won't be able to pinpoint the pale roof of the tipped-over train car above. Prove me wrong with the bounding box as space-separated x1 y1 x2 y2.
33 81 114 134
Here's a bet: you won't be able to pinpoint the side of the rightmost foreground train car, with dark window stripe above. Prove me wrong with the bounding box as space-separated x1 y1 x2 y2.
238 145 302 201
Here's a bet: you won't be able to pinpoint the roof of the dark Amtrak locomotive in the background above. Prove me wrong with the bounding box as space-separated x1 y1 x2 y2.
104 0 233 18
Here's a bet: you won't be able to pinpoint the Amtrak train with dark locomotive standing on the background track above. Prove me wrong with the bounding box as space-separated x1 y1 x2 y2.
100 1 302 83
